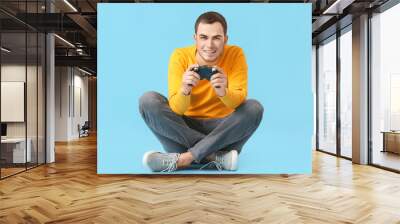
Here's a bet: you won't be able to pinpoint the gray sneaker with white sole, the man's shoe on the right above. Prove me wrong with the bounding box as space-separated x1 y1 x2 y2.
200 150 238 171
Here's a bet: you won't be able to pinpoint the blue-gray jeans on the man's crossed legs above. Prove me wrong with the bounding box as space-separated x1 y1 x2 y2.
139 92 264 163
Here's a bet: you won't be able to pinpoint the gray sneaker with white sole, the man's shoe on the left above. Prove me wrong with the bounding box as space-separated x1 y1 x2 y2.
143 151 179 172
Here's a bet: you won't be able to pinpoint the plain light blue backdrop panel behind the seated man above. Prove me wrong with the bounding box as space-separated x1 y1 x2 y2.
97 3 313 174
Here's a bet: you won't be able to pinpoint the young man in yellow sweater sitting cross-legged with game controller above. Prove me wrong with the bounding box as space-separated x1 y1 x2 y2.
139 12 263 172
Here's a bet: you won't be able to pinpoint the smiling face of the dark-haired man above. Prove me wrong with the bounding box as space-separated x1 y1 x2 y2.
194 22 228 62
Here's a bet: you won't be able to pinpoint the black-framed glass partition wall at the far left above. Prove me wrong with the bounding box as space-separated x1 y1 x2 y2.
0 1 46 179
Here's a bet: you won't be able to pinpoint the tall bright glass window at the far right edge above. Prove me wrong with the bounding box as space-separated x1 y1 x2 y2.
371 4 400 170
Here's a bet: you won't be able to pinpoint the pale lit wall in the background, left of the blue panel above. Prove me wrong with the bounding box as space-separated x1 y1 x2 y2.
55 67 88 141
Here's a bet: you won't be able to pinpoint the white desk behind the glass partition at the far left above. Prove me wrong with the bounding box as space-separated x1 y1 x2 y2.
1 138 32 163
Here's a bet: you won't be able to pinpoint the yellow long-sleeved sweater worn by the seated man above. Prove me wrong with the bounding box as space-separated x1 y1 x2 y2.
168 45 247 119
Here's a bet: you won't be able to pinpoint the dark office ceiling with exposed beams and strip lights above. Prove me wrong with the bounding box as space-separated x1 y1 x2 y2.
0 0 394 75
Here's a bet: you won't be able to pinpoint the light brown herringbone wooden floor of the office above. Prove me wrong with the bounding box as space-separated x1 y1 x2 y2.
0 134 400 224
